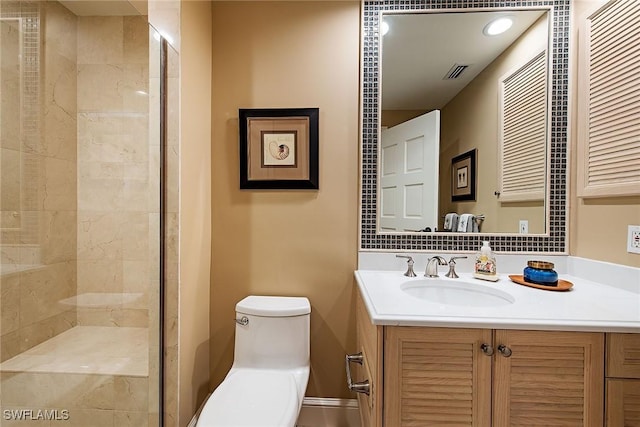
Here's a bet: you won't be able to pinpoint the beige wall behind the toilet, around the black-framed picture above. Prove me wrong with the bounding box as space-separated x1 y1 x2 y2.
210 1 360 397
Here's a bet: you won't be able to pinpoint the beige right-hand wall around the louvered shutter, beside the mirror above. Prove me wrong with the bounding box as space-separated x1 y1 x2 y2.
569 0 640 267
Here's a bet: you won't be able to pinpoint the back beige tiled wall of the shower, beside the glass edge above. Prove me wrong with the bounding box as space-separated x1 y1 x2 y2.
77 16 150 327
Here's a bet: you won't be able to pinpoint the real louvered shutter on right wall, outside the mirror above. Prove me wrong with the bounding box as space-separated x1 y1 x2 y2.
578 0 640 197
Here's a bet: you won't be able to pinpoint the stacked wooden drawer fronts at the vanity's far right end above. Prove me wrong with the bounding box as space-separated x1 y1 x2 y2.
606 333 640 427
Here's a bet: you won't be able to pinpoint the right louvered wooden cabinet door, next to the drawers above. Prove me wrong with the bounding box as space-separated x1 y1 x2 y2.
491 330 604 427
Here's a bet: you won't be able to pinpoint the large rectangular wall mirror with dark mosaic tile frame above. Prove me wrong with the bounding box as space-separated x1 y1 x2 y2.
361 0 570 253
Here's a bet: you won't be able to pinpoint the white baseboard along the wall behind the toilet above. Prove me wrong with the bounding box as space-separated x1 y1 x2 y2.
187 396 360 427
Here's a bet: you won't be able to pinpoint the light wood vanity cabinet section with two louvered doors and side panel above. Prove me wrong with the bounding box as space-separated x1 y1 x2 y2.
357 294 604 427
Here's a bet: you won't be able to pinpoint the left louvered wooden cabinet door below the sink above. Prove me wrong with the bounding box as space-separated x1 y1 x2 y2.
384 327 491 427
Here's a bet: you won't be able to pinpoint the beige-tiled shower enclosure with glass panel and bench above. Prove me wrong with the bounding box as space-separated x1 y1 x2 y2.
0 0 163 427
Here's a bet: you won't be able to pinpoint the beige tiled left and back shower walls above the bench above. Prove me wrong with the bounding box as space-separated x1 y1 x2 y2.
0 1 152 354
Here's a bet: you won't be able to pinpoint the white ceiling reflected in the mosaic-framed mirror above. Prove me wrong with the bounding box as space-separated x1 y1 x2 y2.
381 10 546 110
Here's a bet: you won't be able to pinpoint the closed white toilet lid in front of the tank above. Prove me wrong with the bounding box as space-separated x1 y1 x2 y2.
196 369 300 427
